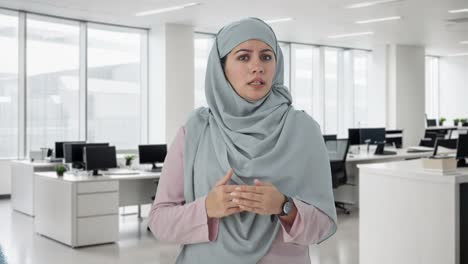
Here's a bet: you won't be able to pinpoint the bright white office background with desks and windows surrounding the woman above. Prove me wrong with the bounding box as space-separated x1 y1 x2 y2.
0 0 468 264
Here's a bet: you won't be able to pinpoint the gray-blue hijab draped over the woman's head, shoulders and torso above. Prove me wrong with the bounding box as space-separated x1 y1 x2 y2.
177 18 336 264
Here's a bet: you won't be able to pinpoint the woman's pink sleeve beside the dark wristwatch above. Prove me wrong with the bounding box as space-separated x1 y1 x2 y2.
280 198 332 246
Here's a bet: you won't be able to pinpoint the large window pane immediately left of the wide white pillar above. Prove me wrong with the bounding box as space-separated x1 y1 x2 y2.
87 24 147 149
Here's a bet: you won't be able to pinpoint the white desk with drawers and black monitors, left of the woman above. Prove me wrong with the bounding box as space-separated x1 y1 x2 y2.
34 172 160 247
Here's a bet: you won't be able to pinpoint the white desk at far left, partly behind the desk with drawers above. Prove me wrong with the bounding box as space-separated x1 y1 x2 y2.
10 160 57 216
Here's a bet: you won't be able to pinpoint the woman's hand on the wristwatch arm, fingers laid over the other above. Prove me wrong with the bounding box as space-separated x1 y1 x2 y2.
231 180 285 215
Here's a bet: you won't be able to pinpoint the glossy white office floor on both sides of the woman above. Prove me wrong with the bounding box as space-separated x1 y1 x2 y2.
0 199 359 264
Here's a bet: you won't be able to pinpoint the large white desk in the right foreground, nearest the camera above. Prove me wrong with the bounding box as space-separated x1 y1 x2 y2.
358 160 468 264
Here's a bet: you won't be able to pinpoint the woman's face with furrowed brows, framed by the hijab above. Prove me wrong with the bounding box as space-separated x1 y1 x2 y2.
224 40 276 101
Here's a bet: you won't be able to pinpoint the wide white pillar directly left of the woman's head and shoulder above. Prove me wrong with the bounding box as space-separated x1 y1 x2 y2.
149 24 195 144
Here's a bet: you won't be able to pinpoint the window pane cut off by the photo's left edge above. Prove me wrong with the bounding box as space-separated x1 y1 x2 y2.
0 13 19 158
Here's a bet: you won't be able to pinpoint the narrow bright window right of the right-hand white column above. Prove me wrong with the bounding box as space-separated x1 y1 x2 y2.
426 56 440 118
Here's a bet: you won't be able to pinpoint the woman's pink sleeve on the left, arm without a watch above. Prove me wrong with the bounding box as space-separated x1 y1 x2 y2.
148 127 219 244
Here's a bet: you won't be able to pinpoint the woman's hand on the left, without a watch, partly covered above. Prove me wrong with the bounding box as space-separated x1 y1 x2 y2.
205 169 243 218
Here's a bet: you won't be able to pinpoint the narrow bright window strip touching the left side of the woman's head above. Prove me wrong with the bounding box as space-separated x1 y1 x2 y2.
194 34 214 108
